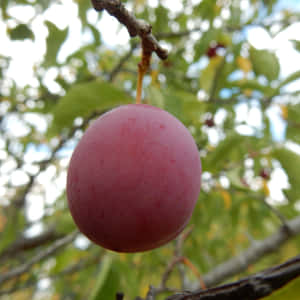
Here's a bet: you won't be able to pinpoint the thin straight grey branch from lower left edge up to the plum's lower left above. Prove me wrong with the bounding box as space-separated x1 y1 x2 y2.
0 231 78 285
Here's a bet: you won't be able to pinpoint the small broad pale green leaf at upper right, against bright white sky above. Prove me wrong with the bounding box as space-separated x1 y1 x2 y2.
250 47 280 81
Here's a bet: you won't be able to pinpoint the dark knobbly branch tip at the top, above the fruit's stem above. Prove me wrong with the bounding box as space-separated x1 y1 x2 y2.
91 0 168 59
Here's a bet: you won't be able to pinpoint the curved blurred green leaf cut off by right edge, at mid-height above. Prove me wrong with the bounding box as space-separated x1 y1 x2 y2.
273 147 300 202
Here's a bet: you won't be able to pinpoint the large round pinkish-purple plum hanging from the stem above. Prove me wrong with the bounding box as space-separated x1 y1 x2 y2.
67 104 201 252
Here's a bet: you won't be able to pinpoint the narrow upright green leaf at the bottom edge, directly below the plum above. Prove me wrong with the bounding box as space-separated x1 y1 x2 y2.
89 253 119 300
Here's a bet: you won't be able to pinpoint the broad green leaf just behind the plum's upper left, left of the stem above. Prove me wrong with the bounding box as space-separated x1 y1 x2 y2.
48 80 132 135
